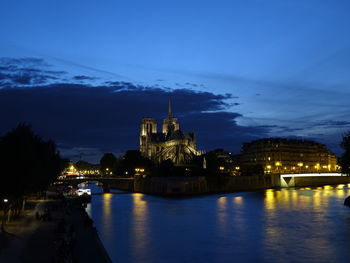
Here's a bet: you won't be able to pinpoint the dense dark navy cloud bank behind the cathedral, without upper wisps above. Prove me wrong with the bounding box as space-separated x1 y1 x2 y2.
0 81 266 162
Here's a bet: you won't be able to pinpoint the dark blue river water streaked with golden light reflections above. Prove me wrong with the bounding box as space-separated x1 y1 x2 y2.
87 185 350 263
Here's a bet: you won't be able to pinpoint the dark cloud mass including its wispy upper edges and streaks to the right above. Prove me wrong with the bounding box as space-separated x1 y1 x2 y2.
0 58 344 162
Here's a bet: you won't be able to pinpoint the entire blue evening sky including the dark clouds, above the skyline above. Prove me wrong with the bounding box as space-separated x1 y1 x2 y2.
0 0 350 162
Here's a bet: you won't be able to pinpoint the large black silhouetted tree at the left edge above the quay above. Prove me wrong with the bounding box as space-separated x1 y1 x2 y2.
0 124 62 228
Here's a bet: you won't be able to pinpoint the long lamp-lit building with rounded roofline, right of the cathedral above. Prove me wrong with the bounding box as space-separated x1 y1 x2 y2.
239 138 338 174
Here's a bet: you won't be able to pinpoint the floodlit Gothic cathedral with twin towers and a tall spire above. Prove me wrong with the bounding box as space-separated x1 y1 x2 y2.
140 100 199 166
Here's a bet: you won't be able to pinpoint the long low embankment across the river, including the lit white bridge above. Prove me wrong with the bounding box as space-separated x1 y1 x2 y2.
103 174 350 196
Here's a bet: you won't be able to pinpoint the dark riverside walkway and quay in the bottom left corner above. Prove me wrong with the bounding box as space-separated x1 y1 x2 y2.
0 197 112 263
